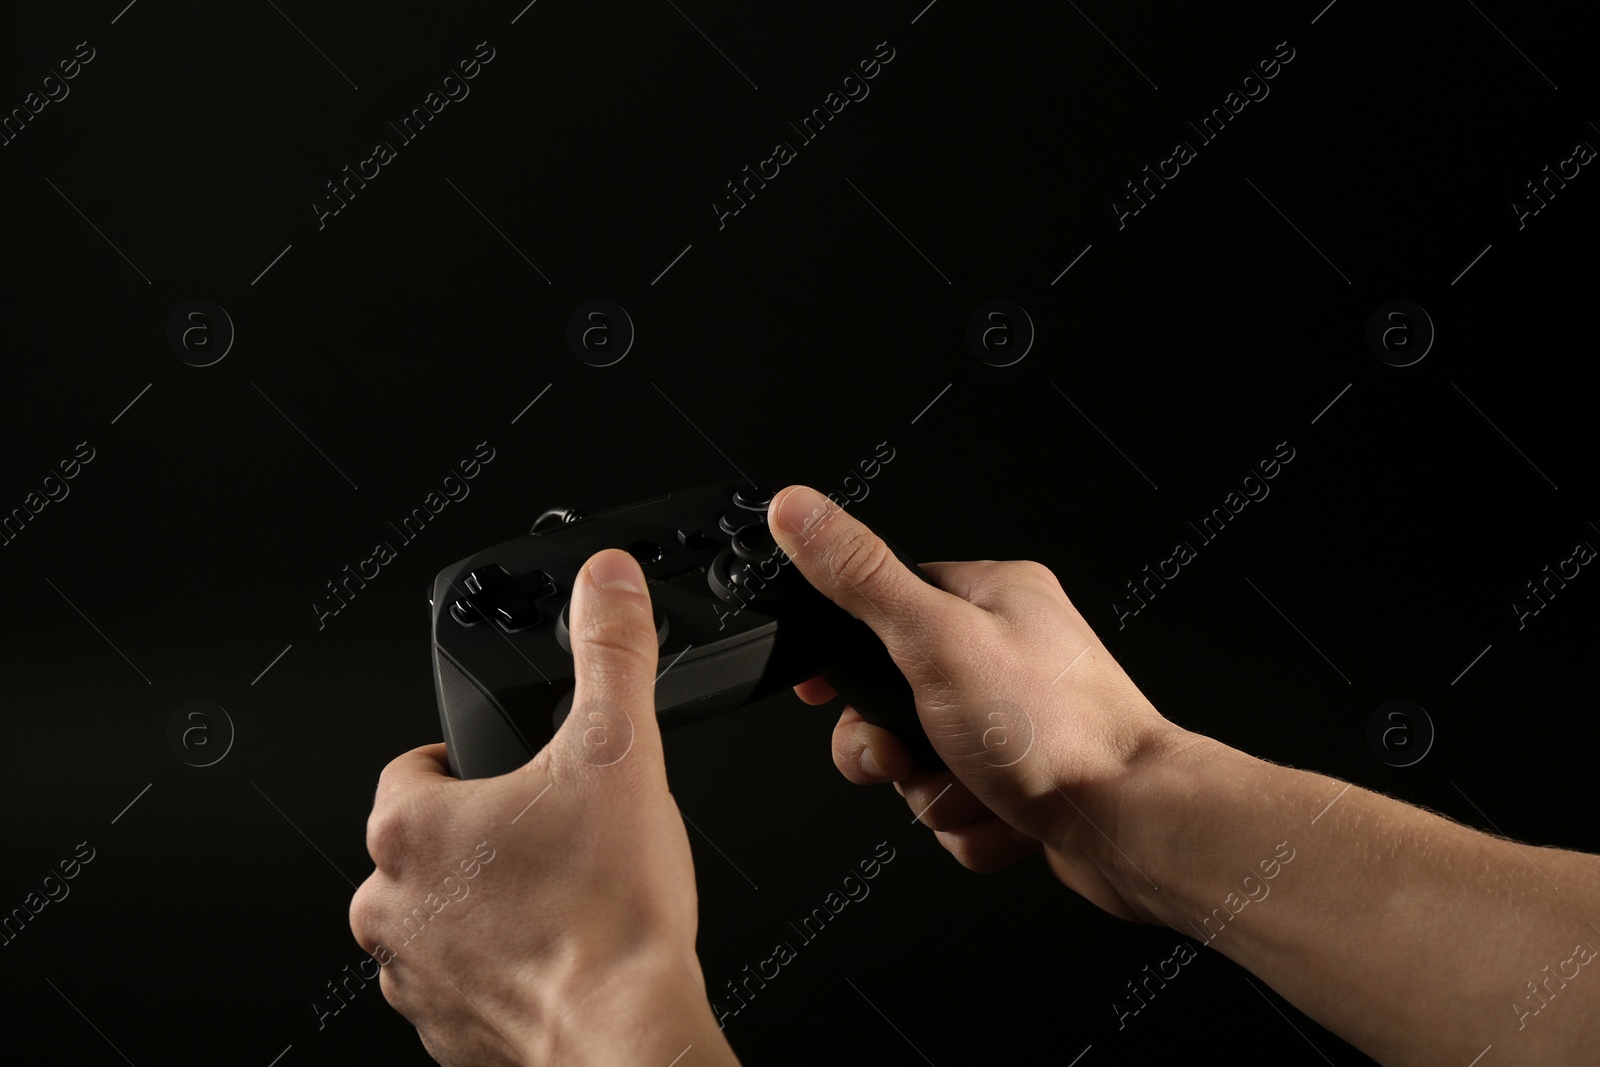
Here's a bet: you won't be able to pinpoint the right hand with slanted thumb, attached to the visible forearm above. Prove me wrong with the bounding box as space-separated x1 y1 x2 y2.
768 486 1192 921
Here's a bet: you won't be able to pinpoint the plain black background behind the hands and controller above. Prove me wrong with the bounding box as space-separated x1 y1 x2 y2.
0 0 1600 1067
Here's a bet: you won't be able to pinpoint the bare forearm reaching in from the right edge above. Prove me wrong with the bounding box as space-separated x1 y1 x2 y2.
1067 731 1600 1065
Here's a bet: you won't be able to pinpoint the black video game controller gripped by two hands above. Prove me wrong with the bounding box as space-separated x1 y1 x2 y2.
430 483 944 779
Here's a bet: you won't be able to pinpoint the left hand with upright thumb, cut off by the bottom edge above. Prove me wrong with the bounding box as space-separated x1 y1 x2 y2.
350 549 736 1067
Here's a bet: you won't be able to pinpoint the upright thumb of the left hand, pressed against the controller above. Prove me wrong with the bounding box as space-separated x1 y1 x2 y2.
550 549 666 789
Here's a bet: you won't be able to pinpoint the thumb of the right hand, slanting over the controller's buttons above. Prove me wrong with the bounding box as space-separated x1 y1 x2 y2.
768 485 978 681
